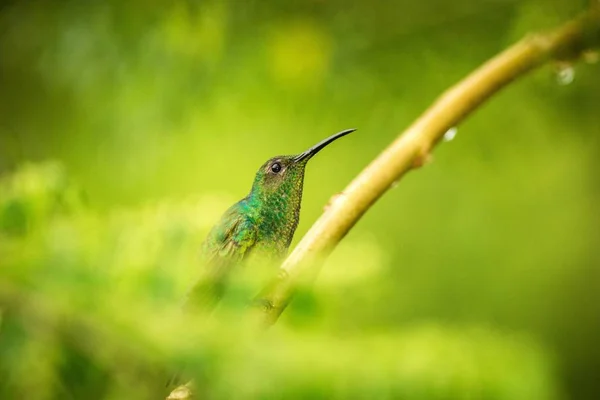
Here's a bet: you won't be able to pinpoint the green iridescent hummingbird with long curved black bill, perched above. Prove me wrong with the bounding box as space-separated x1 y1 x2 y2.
184 129 355 311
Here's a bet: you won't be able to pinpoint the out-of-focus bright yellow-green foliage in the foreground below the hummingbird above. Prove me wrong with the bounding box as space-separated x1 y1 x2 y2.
0 164 557 399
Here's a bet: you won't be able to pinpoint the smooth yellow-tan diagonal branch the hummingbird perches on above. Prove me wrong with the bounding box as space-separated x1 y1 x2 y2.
260 6 600 325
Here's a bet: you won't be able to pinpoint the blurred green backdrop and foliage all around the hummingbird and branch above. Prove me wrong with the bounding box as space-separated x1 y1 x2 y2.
0 0 600 399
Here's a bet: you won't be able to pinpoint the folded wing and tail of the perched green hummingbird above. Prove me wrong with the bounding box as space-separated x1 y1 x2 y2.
185 210 257 311
